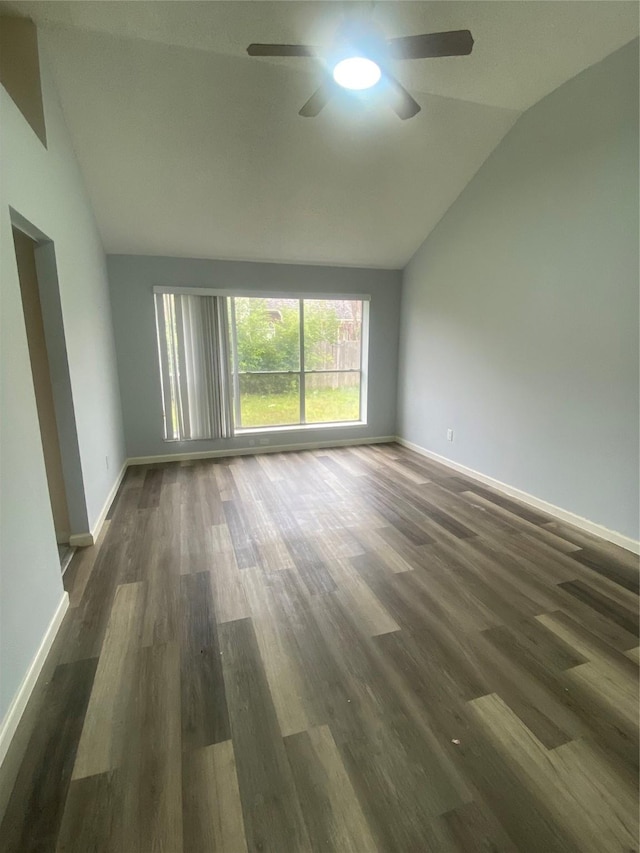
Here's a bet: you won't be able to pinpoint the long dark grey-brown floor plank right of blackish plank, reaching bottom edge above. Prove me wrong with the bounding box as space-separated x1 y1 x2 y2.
220 619 311 853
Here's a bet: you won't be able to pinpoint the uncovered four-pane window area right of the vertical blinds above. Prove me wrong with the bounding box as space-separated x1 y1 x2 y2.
230 296 368 430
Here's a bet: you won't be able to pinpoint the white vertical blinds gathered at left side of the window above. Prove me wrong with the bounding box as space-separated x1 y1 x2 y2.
155 291 233 441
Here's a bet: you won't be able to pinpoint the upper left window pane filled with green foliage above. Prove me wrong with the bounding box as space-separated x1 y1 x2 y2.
235 297 300 370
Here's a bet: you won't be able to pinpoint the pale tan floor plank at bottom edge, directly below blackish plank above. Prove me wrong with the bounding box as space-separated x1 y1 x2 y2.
182 740 247 853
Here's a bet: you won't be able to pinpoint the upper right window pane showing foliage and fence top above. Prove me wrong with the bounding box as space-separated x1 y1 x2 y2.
304 299 362 370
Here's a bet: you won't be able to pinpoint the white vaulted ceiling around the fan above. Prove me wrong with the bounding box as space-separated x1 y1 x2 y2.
11 0 638 268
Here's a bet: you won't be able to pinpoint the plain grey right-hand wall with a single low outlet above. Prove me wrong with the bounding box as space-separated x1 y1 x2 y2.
398 40 639 539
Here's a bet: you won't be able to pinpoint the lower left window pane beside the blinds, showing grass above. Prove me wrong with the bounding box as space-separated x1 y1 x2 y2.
239 373 300 429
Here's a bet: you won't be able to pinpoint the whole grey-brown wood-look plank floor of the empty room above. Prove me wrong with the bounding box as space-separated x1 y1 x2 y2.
0 445 638 853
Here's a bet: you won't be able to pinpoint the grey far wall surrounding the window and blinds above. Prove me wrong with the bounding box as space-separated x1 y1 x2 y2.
107 255 401 457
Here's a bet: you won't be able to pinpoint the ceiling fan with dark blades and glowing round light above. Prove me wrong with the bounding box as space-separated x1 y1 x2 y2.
247 22 473 119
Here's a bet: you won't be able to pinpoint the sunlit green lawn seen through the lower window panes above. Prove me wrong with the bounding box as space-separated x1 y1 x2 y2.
240 385 360 428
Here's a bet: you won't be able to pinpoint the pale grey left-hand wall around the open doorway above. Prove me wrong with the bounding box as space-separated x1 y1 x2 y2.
0 40 125 719
